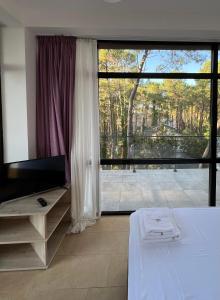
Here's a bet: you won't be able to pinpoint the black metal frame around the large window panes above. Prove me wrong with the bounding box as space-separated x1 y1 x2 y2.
97 40 220 209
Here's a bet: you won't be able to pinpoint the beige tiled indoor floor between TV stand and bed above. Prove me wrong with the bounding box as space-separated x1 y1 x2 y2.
0 216 129 300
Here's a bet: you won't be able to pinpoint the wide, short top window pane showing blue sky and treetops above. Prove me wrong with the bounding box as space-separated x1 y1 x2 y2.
99 49 211 73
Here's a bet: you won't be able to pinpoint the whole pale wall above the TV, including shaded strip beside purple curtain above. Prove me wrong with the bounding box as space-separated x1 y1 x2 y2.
0 27 36 162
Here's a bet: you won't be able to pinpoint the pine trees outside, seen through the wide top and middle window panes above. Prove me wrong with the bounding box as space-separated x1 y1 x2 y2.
99 49 210 164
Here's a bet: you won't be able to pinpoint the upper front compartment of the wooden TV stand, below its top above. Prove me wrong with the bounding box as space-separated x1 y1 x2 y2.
0 218 43 245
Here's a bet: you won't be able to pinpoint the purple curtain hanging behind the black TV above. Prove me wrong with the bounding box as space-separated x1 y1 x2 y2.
36 36 76 182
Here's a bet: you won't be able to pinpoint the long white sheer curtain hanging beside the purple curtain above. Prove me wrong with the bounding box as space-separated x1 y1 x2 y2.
71 39 100 232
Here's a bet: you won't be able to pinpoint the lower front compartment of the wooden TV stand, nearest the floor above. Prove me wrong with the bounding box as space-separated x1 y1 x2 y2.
0 244 46 271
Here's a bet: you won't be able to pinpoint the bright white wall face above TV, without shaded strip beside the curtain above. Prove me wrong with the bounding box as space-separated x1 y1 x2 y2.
0 27 29 162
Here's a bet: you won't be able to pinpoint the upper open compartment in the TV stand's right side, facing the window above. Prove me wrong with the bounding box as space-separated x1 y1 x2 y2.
46 204 70 239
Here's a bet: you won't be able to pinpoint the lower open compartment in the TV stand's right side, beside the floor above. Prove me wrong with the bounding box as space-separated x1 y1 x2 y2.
47 222 70 265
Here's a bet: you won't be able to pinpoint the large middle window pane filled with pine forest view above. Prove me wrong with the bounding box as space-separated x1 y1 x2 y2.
99 79 210 159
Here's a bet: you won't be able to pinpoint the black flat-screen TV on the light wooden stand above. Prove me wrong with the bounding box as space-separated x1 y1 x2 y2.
0 155 65 203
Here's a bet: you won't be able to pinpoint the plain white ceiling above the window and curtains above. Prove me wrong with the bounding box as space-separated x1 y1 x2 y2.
0 0 220 40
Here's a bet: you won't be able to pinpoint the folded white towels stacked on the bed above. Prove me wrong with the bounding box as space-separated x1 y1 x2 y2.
139 208 180 241
